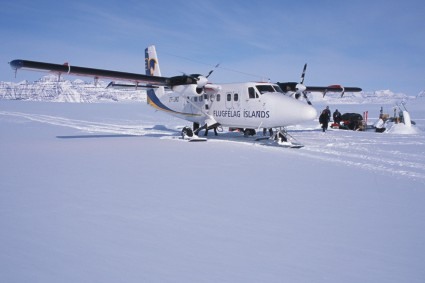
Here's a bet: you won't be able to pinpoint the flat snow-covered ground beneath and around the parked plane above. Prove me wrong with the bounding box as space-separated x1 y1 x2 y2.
0 98 425 282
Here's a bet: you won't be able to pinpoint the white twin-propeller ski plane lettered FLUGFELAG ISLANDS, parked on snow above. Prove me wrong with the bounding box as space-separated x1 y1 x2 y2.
10 45 358 147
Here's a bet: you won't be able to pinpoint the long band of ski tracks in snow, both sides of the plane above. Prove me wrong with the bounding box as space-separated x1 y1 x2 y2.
0 108 425 182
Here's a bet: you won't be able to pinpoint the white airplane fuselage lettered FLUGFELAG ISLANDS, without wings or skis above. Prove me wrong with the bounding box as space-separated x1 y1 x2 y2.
148 82 317 128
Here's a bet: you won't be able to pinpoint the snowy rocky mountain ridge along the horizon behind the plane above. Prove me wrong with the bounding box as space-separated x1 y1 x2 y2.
0 75 425 104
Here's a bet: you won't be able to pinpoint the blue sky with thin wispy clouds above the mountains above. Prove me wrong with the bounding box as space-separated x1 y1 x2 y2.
0 0 425 95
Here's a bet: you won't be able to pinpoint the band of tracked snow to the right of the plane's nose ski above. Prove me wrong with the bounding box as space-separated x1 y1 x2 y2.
292 130 425 182
